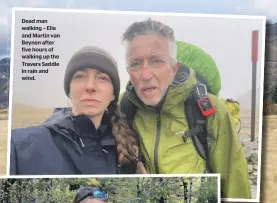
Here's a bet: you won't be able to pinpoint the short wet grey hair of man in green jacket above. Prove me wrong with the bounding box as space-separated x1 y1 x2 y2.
122 18 177 64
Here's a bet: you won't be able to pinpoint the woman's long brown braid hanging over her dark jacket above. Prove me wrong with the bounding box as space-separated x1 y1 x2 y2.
108 102 138 165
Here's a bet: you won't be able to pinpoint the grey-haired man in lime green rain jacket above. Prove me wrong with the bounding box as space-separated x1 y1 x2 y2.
118 19 251 199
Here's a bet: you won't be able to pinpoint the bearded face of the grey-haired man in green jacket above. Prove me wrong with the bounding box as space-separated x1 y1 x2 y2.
126 34 178 106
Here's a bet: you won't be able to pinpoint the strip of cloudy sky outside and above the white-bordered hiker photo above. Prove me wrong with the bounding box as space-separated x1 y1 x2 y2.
0 0 277 57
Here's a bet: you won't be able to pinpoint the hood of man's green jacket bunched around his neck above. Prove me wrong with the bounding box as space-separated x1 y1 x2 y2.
126 66 197 111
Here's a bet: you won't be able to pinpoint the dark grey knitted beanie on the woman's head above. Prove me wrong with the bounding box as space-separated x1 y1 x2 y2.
64 46 120 102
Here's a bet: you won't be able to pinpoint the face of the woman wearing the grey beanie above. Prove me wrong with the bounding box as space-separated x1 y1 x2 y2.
69 68 115 117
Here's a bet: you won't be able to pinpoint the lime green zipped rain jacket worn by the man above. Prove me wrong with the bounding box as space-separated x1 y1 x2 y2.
120 69 251 199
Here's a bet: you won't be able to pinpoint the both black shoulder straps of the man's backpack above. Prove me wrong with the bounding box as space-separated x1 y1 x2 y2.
120 66 214 173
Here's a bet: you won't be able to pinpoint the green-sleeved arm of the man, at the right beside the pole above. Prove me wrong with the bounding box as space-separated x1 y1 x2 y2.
208 96 251 199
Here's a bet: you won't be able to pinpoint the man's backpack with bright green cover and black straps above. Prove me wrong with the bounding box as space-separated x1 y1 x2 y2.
120 41 240 173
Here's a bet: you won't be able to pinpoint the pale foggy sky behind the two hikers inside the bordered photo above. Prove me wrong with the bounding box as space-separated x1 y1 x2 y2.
10 11 263 107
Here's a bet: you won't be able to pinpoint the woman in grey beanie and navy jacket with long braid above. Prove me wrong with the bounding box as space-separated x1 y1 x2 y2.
10 47 144 175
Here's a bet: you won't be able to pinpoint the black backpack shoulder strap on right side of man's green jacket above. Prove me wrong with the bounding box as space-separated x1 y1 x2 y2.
183 93 212 173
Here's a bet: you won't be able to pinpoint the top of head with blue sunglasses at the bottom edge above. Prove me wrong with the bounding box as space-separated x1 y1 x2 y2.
73 187 108 203
